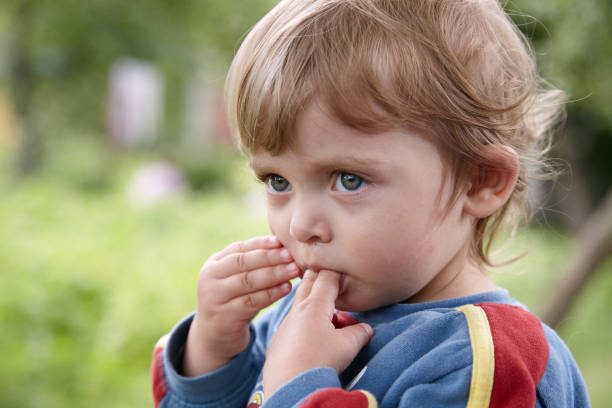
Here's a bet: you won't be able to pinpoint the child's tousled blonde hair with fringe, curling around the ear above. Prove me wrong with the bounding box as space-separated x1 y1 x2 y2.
226 0 565 265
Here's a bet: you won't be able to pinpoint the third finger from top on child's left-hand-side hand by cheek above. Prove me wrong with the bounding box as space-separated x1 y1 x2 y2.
222 262 300 299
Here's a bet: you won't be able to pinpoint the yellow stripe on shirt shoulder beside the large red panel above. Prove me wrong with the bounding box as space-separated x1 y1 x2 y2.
456 305 495 408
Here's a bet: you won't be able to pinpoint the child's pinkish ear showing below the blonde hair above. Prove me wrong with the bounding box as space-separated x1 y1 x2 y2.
463 144 520 218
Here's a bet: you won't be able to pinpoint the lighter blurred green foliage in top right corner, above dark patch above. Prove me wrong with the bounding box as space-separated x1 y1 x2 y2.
515 0 612 126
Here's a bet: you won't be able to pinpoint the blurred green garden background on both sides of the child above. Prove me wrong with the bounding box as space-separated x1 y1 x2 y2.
0 0 612 407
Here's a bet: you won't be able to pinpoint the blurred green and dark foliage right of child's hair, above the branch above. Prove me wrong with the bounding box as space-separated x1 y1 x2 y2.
507 0 612 225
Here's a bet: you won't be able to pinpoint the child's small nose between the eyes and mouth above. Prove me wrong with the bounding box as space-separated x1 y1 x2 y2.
289 197 332 243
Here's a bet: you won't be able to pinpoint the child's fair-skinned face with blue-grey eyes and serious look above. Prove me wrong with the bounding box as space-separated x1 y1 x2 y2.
252 104 472 311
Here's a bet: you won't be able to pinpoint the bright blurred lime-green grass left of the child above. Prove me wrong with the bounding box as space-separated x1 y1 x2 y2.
0 148 266 408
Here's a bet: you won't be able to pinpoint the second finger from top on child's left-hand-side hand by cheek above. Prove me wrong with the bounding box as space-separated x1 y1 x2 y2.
214 248 293 278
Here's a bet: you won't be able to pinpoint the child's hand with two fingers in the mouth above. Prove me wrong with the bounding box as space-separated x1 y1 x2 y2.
263 270 374 395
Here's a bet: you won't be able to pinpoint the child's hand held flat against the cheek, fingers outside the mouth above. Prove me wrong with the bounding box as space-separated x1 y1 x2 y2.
182 236 299 377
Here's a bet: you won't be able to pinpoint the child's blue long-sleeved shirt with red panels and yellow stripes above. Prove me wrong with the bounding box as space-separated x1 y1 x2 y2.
152 289 590 408
